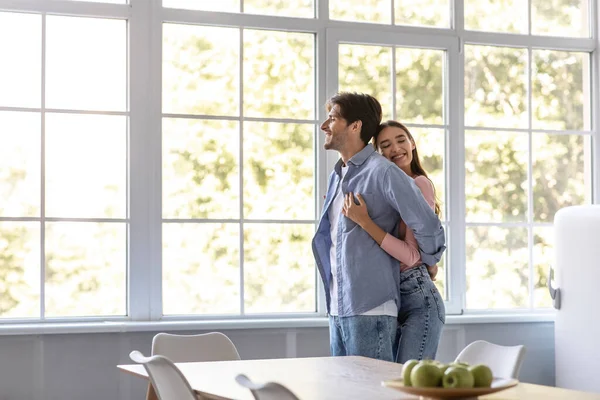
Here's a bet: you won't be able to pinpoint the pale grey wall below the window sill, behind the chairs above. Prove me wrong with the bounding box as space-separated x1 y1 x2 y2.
0 322 554 400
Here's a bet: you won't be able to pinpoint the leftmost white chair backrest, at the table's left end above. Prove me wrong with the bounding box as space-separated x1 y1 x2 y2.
129 350 196 400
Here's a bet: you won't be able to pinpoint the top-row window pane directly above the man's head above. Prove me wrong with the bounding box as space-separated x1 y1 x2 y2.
329 0 392 24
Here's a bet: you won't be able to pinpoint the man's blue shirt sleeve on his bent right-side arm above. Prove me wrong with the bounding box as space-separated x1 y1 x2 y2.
381 166 446 265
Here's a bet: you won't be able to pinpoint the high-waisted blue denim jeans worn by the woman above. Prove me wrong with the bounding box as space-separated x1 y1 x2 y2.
394 265 446 364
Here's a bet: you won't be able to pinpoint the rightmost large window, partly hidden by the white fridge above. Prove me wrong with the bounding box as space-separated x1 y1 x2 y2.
465 45 592 309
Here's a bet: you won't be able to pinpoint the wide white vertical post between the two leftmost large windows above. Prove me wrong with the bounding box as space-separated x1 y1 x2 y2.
128 0 162 321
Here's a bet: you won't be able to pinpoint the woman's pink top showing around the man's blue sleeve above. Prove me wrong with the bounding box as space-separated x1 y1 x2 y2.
381 175 435 271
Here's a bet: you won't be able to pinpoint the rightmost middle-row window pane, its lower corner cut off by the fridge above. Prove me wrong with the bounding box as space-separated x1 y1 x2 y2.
532 133 592 222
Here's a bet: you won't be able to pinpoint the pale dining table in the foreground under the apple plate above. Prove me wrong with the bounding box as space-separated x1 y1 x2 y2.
117 357 600 400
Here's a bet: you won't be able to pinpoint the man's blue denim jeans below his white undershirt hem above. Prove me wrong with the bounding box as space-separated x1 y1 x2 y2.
329 315 398 361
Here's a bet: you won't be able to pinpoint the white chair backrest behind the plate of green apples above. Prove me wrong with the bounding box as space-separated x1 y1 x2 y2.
456 340 525 379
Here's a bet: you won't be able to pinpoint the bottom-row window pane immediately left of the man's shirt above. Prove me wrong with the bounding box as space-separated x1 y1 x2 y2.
244 224 316 313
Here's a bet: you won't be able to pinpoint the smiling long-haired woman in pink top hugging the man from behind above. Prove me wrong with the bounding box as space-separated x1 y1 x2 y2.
342 121 446 363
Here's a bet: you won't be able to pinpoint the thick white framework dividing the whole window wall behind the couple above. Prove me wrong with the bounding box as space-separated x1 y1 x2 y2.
0 0 600 334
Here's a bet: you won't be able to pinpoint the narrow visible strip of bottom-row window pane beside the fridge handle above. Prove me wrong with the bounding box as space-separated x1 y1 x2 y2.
533 226 555 308
